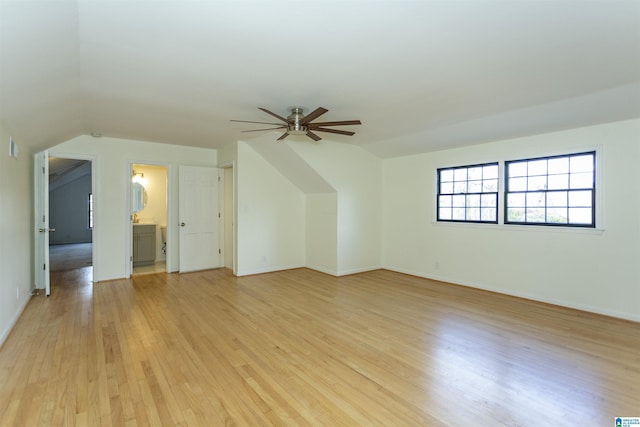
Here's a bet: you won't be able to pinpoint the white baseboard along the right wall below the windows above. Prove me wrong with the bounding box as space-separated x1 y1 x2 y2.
383 266 640 322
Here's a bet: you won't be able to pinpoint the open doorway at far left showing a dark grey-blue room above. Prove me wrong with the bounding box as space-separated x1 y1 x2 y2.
45 157 93 277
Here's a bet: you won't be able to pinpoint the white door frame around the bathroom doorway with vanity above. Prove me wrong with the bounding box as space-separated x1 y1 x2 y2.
124 160 176 278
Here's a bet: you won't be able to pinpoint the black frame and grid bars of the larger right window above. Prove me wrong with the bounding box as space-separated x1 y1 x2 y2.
503 150 598 229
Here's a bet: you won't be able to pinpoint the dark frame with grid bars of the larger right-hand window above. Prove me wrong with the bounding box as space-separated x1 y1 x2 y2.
503 150 597 228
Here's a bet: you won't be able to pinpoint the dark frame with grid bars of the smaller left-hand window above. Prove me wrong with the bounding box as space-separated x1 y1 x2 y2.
436 162 500 224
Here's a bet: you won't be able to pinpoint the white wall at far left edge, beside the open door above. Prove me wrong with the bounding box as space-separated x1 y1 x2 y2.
0 124 33 345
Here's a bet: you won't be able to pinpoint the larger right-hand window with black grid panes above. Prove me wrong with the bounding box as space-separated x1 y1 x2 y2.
504 152 596 227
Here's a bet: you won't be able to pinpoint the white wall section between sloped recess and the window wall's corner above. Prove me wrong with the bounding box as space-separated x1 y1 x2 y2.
290 139 382 275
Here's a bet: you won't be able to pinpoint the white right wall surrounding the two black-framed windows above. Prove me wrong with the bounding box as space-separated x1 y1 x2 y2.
382 120 640 320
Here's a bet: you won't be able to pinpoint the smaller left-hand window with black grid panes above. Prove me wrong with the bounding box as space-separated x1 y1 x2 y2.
437 162 498 223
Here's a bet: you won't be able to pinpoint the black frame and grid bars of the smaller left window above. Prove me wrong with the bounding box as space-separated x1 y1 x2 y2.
436 161 501 224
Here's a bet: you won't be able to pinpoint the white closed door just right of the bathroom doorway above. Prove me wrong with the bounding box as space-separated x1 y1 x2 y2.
178 166 222 273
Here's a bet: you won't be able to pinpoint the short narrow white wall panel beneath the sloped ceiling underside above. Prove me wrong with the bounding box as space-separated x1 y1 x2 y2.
305 193 338 276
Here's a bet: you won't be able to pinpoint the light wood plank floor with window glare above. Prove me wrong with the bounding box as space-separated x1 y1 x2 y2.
0 269 640 427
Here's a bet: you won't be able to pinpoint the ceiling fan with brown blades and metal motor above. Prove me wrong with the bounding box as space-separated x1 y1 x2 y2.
231 107 361 141
